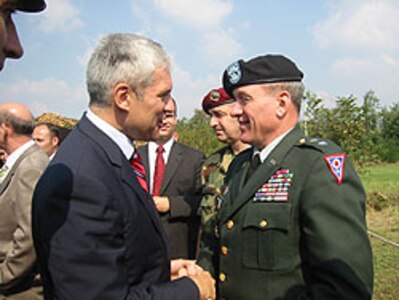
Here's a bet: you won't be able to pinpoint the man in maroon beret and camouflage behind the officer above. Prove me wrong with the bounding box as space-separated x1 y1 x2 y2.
197 88 249 270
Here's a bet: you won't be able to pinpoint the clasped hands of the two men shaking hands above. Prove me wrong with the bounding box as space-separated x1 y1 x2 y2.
170 259 216 300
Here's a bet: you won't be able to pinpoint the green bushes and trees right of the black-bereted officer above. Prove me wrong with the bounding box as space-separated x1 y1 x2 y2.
302 91 399 167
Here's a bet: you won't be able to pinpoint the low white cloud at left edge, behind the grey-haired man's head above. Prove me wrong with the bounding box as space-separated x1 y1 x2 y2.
0 78 88 118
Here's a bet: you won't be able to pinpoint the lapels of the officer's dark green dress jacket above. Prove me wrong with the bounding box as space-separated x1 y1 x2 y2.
220 125 304 222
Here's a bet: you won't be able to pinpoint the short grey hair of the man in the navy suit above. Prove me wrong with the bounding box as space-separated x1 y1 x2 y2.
86 33 170 107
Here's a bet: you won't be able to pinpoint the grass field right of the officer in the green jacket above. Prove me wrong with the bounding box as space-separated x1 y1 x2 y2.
361 164 399 300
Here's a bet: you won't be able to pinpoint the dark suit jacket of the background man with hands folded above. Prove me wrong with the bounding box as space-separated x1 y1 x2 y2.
138 142 205 259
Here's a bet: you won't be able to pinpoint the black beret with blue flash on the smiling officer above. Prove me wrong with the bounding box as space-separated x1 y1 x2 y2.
223 54 303 96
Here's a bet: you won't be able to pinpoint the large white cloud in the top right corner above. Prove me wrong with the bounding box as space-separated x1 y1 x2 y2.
313 0 399 51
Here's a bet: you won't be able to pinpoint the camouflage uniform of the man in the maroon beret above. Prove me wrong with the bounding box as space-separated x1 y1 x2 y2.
197 146 234 270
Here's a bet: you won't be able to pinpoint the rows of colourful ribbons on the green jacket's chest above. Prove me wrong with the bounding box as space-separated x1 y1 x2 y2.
253 169 294 202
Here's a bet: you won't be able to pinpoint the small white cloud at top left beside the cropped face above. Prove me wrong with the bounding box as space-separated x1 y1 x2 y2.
40 0 84 32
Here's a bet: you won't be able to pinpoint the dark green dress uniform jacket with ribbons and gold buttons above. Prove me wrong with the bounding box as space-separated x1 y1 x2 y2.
208 126 373 300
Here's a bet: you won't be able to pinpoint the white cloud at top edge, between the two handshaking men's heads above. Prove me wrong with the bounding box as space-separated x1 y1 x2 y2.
154 0 233 29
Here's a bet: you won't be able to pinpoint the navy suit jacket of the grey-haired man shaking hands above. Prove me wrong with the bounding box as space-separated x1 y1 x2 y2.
33 117 199 300
